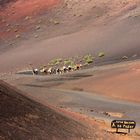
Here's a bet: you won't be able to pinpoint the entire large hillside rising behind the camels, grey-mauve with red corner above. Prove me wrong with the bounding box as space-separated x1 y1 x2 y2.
0 0 140 72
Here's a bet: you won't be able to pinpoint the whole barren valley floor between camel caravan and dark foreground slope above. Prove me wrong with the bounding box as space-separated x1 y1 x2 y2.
3 61 140 139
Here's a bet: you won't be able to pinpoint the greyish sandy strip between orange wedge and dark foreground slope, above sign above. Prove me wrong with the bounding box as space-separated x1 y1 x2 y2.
15 87 140 128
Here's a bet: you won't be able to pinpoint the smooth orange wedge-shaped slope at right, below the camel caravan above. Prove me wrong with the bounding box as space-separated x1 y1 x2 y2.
58 61 140 103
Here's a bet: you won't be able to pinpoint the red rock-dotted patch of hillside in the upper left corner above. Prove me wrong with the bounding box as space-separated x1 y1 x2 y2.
0 0 60 46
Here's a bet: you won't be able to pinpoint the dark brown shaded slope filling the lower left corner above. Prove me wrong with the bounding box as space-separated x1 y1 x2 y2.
0 81 96 140
